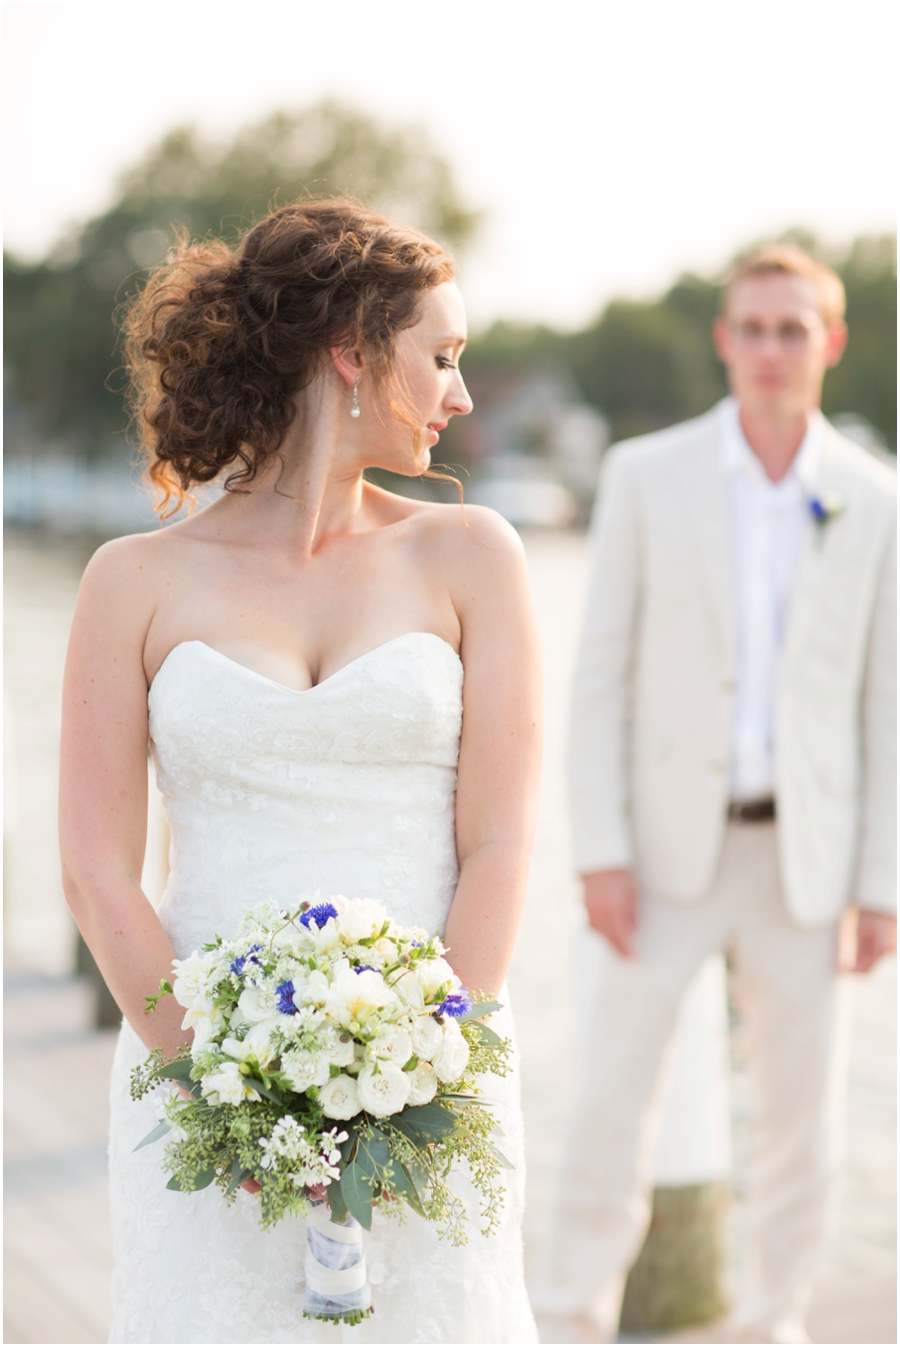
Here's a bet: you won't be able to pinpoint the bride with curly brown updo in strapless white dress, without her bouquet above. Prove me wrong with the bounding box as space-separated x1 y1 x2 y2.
61 201 540 1343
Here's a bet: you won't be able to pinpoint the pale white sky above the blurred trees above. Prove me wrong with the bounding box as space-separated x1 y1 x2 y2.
3 0 897 329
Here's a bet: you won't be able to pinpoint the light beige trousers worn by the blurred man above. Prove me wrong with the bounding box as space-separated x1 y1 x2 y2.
535 823 847 1340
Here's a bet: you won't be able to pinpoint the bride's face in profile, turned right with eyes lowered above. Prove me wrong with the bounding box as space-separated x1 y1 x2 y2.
360 282 472 477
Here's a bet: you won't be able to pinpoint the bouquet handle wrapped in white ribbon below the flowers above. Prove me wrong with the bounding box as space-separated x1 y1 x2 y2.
303 1202 372 1324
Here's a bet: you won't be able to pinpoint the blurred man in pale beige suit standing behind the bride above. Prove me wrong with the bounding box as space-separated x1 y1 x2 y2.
540 245 896 1342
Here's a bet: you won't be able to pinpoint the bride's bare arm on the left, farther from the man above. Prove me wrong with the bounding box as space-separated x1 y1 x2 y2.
59 539 190 1056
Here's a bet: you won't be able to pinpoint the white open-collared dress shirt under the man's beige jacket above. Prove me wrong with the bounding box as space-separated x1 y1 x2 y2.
722 397 823 800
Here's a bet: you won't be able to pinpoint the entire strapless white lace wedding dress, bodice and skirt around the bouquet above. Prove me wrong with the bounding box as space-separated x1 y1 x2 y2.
109 632 538 1343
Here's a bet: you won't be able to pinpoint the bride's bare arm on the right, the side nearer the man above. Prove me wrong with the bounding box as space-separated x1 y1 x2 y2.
445 508 542 994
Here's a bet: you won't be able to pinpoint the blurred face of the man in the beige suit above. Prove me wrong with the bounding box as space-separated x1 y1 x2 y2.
715 272 846 419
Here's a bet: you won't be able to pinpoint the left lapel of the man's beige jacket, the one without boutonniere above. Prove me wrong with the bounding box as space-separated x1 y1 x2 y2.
680 408 736 672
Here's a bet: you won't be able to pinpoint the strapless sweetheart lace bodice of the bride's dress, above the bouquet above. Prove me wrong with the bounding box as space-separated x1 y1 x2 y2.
150 632 462 958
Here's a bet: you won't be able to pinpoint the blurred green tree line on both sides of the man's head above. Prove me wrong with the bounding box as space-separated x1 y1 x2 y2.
458 230 897 449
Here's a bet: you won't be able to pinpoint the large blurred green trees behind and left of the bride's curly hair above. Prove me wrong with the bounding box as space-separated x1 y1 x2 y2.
4 100 477 455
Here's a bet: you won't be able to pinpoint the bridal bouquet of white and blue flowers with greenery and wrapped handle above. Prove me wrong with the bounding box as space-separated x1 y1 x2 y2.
132 896 509 1323
